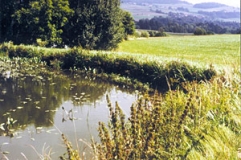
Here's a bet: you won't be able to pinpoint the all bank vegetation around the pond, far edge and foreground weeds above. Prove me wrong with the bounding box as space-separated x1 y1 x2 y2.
0 34 241 160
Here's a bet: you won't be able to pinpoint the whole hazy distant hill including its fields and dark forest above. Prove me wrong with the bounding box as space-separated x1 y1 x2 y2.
121 0 240 34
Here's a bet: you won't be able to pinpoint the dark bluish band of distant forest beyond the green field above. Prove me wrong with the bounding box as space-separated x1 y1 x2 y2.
136 12 240 34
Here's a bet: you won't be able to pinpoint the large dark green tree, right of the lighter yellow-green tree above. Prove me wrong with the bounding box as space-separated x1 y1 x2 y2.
64 0 124 50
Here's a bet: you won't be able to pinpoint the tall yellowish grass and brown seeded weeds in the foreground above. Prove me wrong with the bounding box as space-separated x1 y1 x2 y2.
95 70 241 159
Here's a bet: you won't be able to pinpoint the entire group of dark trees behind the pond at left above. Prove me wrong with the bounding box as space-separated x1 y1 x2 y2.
0 0 135 50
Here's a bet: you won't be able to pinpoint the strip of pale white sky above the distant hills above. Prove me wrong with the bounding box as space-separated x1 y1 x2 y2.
184 0 240 8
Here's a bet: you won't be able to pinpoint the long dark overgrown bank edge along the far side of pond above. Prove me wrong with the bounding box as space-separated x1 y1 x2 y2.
0 43 217 91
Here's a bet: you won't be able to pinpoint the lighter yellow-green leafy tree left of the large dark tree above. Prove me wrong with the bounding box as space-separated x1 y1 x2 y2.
13 0 73 45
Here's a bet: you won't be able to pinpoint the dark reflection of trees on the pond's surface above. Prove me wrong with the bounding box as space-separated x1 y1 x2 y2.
0 71 110 134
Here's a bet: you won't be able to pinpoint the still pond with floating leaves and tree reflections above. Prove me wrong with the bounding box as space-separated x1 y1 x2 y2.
0 58 137 160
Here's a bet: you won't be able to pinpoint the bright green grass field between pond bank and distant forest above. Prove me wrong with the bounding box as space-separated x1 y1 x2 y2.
117 35 240 66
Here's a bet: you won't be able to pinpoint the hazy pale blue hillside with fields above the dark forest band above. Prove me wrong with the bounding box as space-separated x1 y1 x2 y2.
121 0 240 22
